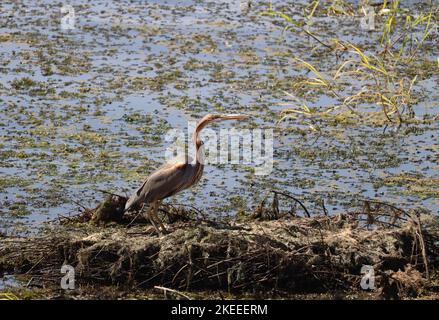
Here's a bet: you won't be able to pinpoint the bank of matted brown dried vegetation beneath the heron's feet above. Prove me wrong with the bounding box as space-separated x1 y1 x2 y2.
0 199 439 299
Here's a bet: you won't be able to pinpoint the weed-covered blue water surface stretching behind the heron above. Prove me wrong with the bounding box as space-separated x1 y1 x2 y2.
0 0 439 234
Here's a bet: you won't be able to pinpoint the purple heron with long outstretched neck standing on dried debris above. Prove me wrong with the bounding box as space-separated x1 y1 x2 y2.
125 114 248 234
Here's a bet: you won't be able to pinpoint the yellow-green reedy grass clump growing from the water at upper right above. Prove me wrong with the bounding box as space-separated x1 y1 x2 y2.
262 1 437 131
